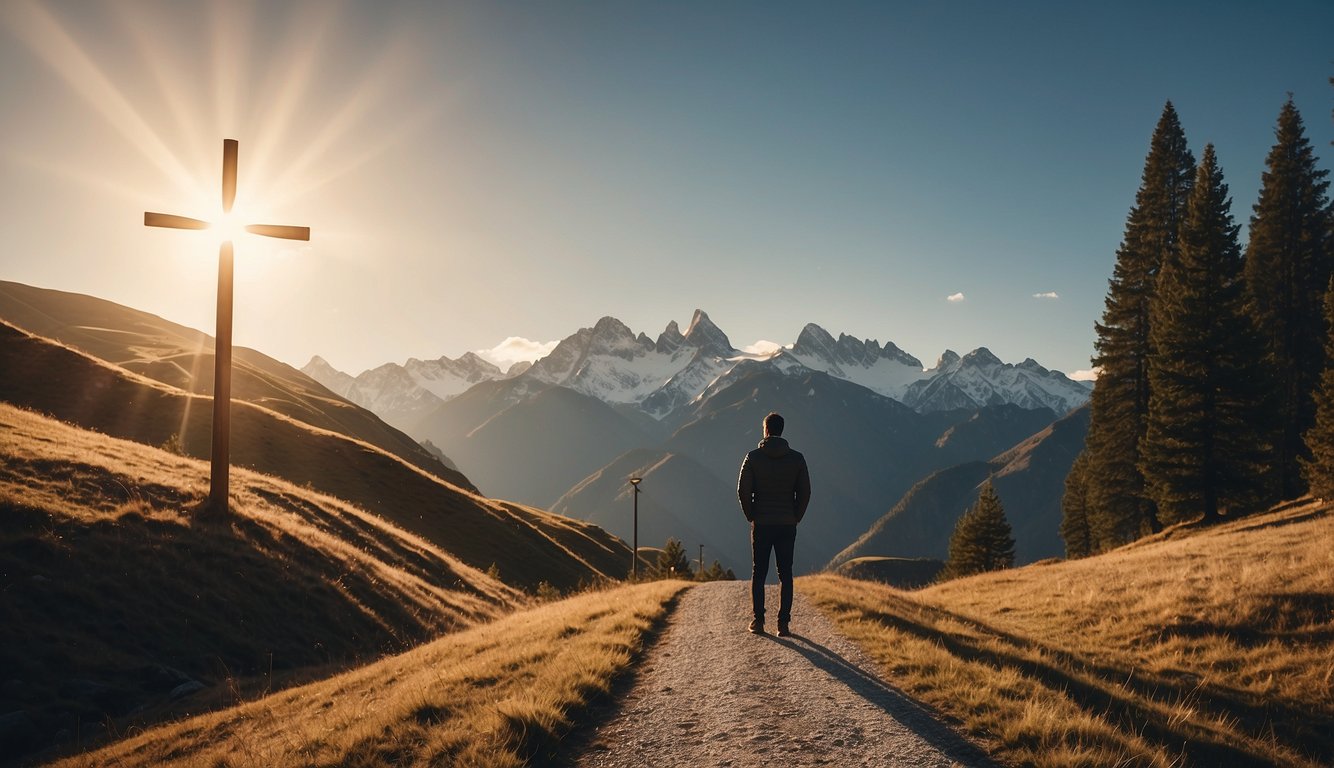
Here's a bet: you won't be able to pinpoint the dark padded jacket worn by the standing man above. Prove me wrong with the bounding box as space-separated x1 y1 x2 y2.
736 437 811 525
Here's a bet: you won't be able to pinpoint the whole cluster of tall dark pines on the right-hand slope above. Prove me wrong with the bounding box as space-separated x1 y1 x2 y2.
1061 93 1334 557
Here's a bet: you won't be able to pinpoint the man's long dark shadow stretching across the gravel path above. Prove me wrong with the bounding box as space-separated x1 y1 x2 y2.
763 635 998 768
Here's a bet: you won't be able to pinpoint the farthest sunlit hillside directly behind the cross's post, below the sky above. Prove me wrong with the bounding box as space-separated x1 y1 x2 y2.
0 281 453 488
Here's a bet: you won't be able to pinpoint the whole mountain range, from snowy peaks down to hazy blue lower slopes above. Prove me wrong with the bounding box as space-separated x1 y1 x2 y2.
303 311 1090 572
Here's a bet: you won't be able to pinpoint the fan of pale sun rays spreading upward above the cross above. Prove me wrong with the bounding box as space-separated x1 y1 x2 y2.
0 0 439 251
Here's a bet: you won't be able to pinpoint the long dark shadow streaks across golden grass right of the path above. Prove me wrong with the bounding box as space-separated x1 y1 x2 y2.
864 599 1334 767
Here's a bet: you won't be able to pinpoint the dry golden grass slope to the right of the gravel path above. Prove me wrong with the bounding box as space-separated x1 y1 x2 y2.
799 503 1334 767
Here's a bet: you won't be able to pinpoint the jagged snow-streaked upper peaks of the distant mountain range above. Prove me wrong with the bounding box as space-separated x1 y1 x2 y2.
301 309 1090 433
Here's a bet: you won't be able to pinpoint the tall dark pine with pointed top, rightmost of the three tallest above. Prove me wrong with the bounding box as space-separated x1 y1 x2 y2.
1246 96 1334 499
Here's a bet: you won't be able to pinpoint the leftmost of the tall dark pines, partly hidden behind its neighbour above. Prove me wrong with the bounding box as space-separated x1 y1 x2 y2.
1086 101 1195 549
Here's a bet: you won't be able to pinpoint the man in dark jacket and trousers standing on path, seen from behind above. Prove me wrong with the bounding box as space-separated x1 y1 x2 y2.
736 413 811 637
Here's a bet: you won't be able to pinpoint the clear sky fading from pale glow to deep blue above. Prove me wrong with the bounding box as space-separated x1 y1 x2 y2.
0 0 1334 373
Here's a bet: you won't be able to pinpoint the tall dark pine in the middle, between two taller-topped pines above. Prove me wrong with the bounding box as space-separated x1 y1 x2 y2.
1141 144 1271 520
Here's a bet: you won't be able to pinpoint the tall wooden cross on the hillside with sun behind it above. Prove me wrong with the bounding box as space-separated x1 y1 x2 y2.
144 139 311 512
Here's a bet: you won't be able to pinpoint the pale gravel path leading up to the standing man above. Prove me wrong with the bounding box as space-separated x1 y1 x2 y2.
574 581 991 768
